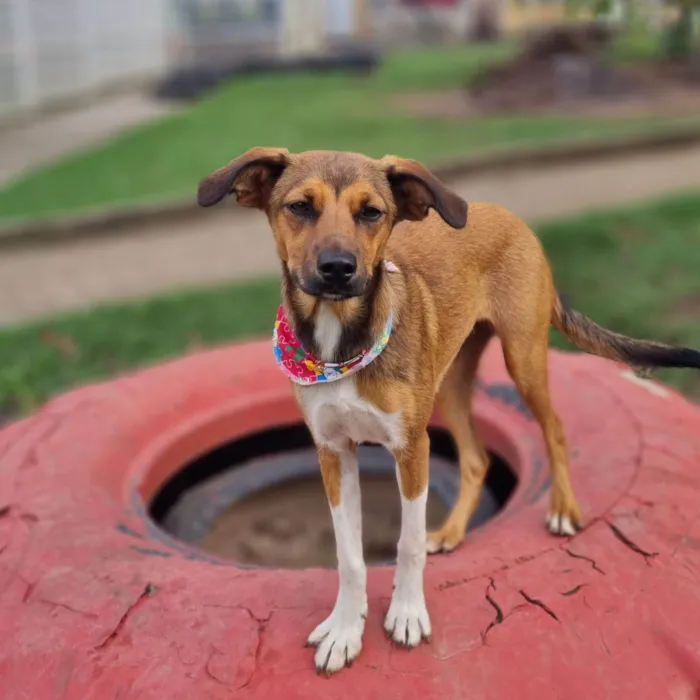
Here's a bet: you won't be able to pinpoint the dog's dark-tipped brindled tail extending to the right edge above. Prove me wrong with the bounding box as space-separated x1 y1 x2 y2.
552 292 700 370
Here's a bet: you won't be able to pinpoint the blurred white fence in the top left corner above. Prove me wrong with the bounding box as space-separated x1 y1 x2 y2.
0 0 168 115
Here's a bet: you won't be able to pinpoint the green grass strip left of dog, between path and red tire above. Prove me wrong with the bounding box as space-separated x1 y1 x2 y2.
0 279 280 415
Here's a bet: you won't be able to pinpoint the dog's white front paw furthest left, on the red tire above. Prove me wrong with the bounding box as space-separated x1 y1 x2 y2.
307 604 367 674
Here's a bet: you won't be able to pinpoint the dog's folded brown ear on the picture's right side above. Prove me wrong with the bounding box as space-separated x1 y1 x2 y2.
379 156 468 228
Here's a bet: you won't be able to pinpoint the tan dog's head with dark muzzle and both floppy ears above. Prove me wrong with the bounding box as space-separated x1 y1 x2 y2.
198 148 467 300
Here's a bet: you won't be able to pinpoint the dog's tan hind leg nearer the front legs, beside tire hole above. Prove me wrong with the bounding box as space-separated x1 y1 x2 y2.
428 322 493 554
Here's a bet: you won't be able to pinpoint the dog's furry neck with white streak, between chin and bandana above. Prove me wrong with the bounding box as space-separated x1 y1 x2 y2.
282 263 391 362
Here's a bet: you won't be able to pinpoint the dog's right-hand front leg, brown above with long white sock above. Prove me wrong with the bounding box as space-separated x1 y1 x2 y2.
384 431 431 647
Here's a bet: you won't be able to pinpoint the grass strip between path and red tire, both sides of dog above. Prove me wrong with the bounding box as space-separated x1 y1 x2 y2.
0 189 700 414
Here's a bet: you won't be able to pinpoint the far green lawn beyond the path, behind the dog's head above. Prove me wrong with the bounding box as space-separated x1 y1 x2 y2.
0 43 696 223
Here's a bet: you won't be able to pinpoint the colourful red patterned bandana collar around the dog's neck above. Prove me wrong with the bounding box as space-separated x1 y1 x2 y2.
272 262 398 386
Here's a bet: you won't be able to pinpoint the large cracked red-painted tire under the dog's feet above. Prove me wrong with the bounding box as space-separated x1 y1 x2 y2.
0 343 700 700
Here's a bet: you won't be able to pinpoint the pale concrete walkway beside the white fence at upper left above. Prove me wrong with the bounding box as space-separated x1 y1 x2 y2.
0 91 174 186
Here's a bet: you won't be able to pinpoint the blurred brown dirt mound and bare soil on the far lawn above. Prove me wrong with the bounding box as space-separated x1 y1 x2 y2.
399 25 700 119
